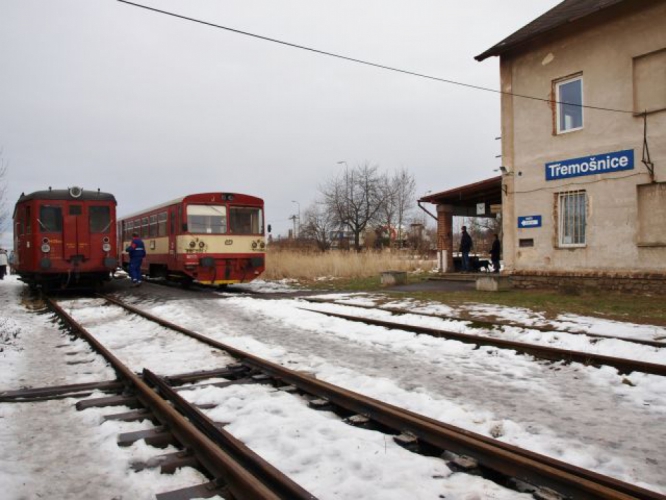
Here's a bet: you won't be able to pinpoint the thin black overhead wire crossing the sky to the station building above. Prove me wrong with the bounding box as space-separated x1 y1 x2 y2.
117 0 634 115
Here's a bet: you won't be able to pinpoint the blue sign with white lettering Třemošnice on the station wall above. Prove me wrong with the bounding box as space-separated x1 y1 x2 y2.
546 149 634 181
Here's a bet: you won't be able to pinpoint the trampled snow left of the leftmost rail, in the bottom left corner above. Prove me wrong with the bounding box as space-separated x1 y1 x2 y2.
0 276 210 500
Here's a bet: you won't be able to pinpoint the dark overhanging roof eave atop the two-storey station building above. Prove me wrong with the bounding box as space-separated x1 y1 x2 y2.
474 0 628 61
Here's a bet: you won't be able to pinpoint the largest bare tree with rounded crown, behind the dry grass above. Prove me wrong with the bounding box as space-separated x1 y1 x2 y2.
319 162 385 251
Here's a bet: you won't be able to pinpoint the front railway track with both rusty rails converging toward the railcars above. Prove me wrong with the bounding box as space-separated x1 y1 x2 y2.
27 297 666 500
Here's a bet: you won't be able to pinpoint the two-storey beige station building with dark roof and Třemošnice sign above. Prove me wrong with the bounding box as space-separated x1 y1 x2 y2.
421 0 666 293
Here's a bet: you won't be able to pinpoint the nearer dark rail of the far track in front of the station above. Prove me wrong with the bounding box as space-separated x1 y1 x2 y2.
298 299 666 376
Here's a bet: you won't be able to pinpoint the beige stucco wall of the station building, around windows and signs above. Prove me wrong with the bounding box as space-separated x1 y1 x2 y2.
500 2 666 274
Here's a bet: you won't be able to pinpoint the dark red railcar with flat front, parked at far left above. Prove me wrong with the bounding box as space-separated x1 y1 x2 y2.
12 187 118 289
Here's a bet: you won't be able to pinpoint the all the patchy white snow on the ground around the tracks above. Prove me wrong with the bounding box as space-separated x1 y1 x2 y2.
0 278 666 500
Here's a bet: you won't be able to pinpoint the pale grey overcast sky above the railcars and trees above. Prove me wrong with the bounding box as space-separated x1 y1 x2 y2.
0 0 559 245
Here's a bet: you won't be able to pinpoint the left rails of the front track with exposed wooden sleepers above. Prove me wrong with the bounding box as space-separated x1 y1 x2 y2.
41 299 315 500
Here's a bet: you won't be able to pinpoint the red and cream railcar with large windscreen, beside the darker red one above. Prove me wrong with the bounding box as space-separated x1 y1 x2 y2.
118 193 266 285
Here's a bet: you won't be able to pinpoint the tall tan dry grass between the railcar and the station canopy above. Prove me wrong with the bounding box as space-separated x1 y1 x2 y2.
262 250 435 281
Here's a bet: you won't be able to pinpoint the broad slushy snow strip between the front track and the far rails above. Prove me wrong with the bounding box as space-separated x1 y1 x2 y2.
122 297 666 491
